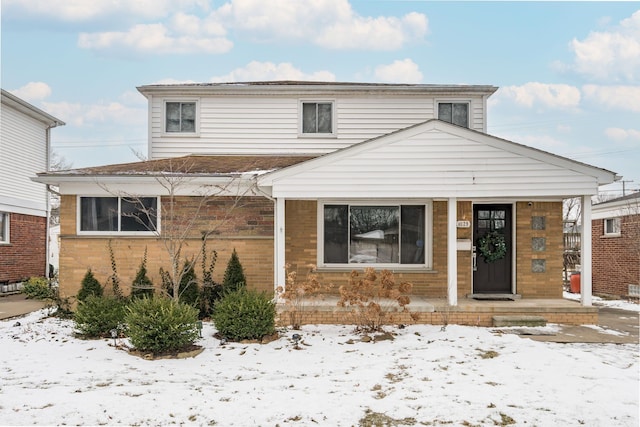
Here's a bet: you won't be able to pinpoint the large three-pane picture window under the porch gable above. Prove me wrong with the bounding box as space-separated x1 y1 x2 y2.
320 203 428 266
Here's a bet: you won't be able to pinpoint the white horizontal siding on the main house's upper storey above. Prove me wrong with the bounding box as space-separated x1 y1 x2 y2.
150 94 484 159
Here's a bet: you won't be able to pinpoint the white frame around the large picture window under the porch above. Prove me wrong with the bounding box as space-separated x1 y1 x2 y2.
317 199 433 271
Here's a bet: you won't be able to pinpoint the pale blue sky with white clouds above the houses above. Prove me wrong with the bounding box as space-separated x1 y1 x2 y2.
1 0 640 196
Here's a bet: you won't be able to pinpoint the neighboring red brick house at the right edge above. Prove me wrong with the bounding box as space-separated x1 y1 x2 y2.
591 192 640 298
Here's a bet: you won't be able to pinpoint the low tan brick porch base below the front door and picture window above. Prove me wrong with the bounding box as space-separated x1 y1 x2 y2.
278 296 598 326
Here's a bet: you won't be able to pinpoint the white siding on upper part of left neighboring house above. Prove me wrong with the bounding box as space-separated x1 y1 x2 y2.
0 104 47 216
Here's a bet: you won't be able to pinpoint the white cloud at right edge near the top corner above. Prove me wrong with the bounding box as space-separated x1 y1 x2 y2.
569 10 640 82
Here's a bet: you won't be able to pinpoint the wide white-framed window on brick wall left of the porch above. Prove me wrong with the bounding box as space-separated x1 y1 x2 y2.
78 197 159 234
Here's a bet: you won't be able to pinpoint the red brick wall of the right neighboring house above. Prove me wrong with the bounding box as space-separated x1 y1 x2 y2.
591 214 640 297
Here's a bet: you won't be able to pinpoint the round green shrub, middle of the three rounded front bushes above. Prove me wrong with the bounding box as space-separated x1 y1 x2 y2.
125 296 199 353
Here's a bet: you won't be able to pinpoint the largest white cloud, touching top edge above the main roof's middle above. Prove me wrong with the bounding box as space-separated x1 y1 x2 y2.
215 0 428 50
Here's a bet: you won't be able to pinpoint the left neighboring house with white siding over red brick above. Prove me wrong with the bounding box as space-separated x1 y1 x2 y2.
0 90 64 291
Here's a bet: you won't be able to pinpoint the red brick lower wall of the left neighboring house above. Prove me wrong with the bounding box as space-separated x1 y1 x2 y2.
0 213 47 283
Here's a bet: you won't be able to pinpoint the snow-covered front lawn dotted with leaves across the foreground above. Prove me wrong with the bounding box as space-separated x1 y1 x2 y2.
0 311 640 427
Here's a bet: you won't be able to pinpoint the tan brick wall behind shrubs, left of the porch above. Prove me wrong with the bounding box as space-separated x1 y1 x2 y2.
60 196 274 296
